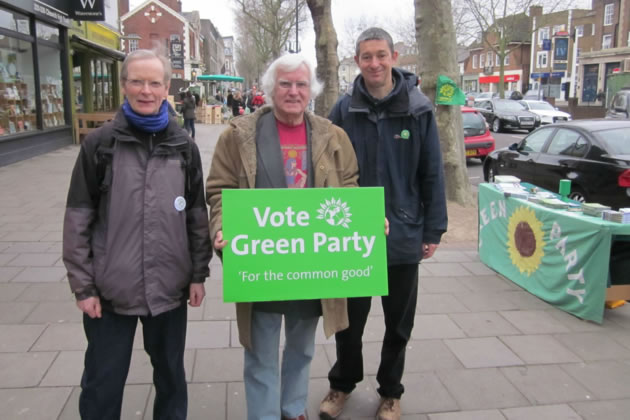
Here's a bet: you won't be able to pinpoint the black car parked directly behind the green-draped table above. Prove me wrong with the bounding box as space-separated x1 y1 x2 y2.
483 119 630 209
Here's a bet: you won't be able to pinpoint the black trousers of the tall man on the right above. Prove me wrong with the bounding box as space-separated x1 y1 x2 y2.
328 264 418 398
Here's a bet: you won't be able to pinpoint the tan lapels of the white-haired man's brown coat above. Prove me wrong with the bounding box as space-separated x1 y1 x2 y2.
230 105 340 172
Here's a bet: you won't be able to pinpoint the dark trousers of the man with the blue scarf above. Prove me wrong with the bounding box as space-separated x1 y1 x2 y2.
79 304 188 420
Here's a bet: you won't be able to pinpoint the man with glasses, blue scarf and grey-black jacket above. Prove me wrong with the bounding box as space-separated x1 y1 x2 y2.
63 50 212 420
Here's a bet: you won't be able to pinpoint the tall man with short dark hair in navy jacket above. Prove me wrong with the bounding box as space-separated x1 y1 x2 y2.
320 28 447 420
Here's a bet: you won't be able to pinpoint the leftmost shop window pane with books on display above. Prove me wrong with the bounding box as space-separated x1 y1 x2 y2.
0 37 37 136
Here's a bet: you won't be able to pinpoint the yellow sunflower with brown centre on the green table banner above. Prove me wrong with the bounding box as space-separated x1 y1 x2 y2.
507 207 545 276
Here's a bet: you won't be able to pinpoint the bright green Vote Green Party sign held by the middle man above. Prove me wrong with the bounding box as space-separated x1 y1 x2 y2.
222 187 387 302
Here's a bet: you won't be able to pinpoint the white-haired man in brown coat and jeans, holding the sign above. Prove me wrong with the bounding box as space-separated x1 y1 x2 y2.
206 54 357 420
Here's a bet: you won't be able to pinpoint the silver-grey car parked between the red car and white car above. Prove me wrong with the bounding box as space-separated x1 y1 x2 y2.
475 99 540 133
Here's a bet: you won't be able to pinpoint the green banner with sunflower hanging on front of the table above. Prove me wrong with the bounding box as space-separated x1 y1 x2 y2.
479 184 611 323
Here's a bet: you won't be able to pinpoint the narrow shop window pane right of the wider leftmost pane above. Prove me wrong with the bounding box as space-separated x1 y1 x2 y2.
37 45 66 128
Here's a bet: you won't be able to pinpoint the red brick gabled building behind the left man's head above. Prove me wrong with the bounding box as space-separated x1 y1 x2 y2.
120 0 204 94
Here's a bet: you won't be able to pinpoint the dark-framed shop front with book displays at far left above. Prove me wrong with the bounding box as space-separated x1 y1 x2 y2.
0 0 72 166
